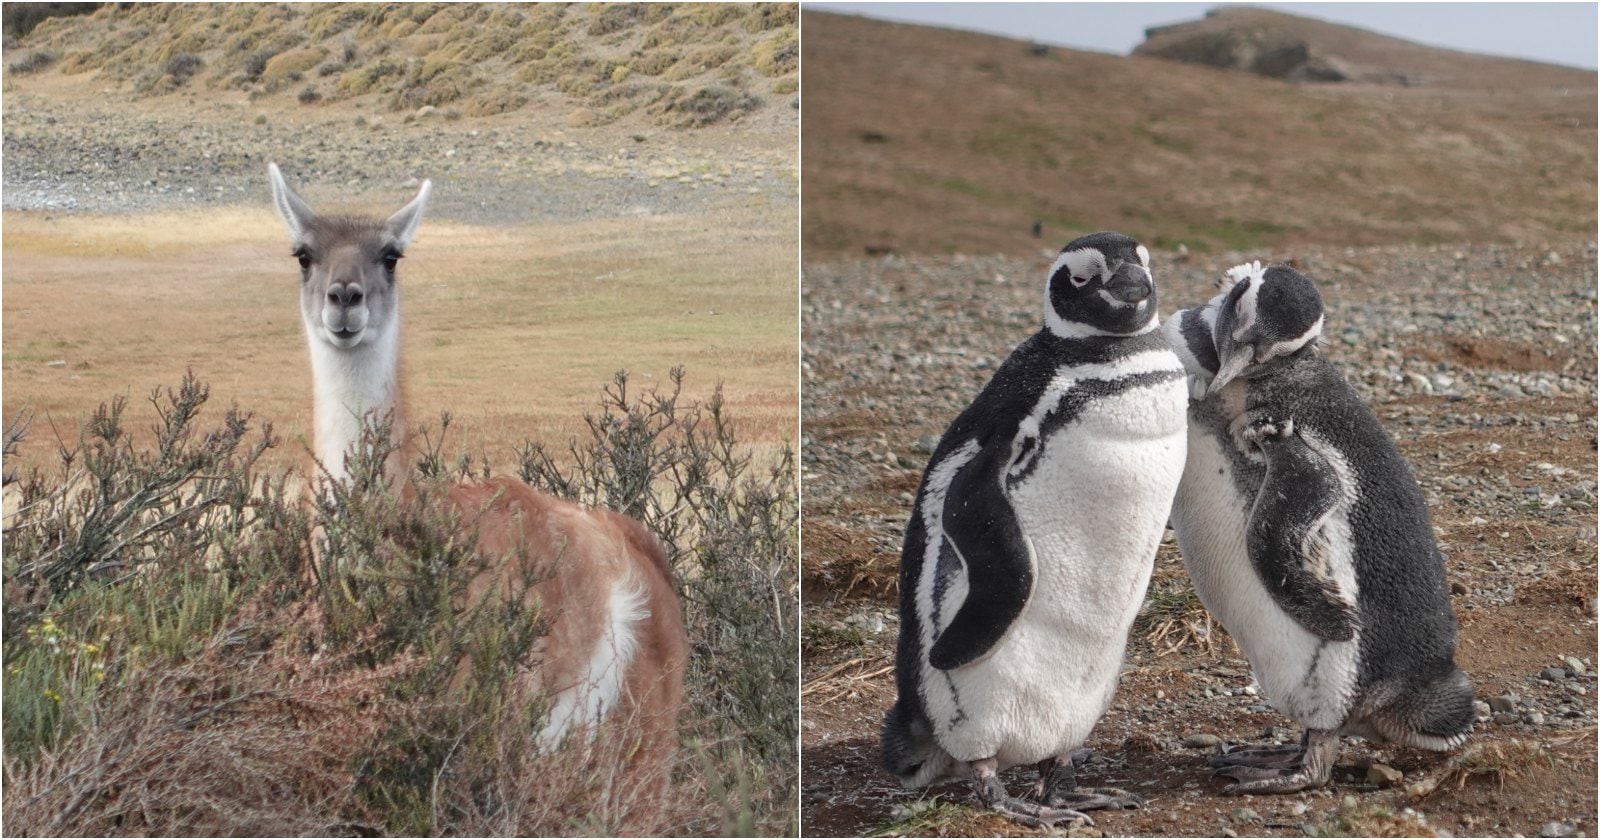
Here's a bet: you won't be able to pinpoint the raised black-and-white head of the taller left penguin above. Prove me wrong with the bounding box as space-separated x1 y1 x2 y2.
1045 230 1155 338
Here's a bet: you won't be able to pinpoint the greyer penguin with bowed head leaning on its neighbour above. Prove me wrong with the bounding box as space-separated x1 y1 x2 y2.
1162 262 1474 794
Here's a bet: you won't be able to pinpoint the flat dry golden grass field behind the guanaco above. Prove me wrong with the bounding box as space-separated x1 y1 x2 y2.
3 203 797 464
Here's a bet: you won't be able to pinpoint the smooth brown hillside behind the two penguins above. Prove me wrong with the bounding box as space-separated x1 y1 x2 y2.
802 11 1597 256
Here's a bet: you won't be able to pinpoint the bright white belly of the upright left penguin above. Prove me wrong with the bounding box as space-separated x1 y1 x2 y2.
923 381 1187 766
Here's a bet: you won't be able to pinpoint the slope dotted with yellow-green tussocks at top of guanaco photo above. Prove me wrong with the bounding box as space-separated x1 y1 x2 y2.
6 3 800 128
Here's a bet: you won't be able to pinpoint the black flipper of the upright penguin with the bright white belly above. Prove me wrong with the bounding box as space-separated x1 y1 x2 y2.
928 446 1034 670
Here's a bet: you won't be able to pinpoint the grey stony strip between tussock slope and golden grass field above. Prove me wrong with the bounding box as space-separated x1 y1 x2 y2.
0 75 797 222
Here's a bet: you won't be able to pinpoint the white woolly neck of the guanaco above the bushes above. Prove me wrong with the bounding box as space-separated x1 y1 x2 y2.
307 323 406 483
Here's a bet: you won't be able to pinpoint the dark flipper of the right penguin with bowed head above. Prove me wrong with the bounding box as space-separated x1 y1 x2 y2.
1243 419 1358 642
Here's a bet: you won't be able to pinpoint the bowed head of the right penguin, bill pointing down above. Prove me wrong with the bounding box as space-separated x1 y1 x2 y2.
1211 262 1322 392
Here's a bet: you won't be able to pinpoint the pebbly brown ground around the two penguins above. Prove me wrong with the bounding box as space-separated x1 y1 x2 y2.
802 242 1597 837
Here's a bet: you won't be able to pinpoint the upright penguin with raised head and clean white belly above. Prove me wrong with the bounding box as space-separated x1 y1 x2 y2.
882 232 1187 826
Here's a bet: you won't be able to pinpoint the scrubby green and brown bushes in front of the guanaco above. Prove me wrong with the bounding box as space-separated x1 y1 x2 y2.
3 371 798 835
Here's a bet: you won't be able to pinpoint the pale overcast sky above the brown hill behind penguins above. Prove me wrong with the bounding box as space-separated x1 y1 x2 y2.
805 2 1600 70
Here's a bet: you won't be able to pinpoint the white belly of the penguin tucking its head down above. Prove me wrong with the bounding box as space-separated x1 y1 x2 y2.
1173 424 1360 730
